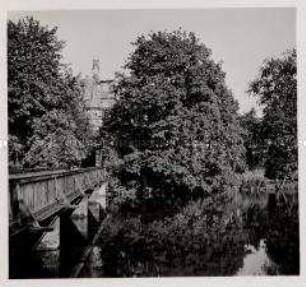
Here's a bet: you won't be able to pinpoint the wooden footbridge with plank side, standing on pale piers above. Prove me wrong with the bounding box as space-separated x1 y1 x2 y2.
9 168 107 277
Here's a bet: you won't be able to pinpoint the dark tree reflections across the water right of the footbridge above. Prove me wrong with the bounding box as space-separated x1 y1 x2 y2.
95 195 299 277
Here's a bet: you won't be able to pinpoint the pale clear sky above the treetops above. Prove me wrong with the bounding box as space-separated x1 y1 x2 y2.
8 8 296 115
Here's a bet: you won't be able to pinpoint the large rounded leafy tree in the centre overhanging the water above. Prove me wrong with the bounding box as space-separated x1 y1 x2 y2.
102 30 244 204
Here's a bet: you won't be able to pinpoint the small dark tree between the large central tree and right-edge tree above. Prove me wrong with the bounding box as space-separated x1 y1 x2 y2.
239 109 266 170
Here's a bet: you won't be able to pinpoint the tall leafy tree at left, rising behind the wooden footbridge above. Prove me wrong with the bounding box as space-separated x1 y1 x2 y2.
7 18 90 171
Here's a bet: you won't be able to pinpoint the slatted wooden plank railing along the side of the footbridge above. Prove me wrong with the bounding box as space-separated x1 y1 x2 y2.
9 168 106 233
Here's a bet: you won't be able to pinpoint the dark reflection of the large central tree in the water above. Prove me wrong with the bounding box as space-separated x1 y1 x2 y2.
102 202 245 277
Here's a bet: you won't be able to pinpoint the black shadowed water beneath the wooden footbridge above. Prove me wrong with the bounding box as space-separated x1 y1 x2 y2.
9 216 99 279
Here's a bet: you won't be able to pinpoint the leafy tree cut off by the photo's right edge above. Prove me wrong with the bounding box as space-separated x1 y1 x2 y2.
249 49 298 178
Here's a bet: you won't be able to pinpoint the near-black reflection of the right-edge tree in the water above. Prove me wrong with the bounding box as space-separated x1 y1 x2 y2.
244 198 299 275
